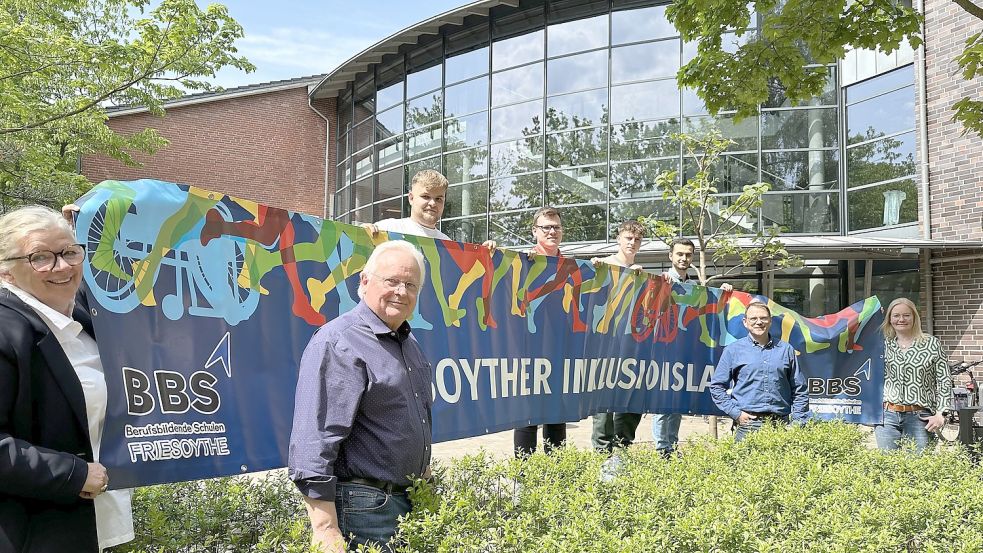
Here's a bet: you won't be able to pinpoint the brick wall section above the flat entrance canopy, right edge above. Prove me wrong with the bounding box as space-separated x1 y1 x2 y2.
925 0 983 240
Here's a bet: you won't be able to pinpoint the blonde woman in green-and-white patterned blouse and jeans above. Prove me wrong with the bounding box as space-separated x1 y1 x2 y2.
874 298 952 451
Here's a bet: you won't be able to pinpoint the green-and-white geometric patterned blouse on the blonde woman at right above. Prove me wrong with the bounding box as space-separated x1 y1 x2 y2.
884 335 952 413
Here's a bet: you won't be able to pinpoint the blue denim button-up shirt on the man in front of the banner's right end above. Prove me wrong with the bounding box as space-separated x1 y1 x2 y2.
710 336 809 421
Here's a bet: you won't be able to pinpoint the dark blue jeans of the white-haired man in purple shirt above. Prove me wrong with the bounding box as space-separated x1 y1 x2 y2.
335 482 411 551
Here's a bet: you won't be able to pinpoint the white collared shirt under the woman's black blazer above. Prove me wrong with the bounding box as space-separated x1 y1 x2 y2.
3 282 134 549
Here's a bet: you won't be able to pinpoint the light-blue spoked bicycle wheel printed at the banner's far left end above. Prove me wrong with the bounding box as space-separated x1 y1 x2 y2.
76 192 149 313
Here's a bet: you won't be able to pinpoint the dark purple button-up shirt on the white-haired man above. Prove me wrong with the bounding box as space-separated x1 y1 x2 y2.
287 301 433 501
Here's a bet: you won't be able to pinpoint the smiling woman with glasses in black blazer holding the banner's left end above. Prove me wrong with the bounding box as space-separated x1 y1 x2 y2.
0 206 133 553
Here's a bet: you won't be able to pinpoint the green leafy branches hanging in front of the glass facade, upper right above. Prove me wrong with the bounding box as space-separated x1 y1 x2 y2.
666 0 983 136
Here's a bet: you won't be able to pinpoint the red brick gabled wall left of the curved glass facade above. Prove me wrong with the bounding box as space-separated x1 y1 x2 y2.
82 86 337 216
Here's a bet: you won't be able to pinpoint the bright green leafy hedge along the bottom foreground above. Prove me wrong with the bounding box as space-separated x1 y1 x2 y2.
107 423 983 553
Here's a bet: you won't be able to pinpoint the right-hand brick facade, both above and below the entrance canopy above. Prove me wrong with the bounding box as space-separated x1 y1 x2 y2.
922 0 983 360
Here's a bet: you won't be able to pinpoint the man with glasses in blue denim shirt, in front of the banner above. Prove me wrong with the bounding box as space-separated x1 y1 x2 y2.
710 302 809 441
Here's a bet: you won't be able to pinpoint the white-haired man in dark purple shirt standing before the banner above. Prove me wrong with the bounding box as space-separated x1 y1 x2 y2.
287 240 432 553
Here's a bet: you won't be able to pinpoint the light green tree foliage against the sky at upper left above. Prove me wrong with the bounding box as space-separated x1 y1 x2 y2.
0 0 253 211
